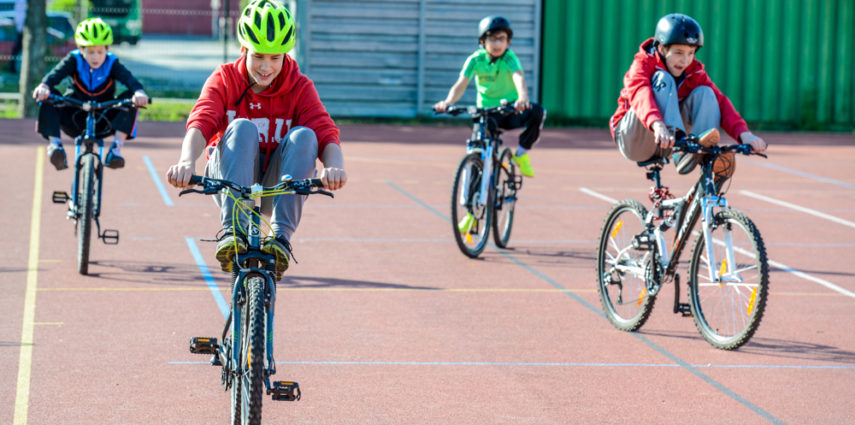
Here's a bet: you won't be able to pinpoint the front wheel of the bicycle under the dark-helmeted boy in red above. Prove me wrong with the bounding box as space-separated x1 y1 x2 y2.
689 209 769 350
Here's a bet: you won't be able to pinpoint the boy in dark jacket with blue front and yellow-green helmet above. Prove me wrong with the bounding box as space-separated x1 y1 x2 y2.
33 18 149 170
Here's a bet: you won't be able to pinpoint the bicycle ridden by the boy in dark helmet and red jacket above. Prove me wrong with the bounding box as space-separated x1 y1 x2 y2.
597 136 769 350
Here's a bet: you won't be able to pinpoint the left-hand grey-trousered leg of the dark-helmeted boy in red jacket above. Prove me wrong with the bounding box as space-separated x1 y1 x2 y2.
615 71 685 162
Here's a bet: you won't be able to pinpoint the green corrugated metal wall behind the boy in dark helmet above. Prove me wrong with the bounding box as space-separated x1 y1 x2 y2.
542 0 855 129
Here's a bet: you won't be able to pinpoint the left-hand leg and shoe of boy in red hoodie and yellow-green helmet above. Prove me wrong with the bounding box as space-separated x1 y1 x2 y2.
205 119 258 271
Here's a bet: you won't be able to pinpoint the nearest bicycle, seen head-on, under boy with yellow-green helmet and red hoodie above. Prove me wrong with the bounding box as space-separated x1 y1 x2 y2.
184 175 333 425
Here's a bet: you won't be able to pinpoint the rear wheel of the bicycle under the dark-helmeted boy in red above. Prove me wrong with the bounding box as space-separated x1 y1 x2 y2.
596 200 657 332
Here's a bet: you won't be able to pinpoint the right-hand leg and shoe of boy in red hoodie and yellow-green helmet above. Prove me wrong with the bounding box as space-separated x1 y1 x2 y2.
261 127 318 280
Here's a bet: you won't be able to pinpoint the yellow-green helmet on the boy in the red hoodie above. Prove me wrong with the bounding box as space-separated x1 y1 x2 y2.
237 0 297 54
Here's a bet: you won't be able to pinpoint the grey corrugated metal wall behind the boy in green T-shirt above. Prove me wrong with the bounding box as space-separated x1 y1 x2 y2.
294 0 541 117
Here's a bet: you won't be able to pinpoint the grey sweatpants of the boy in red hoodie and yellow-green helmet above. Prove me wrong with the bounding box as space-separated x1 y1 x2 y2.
205 119 318 240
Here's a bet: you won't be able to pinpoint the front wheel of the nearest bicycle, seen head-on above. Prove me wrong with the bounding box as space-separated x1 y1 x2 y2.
233 276 266 425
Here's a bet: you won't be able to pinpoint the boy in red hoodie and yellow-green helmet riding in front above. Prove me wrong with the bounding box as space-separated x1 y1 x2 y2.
166 0 347 280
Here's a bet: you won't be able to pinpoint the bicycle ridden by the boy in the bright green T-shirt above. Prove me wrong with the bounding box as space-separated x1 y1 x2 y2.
446 104 522 258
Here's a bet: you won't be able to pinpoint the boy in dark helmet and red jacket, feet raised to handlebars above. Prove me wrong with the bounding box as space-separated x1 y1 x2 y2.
609 13 766 181
